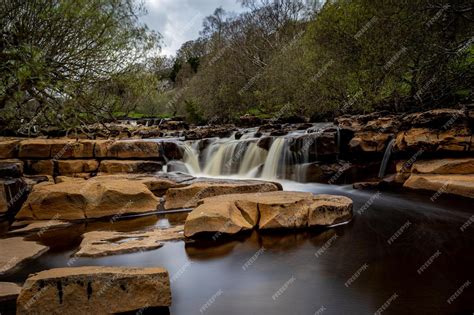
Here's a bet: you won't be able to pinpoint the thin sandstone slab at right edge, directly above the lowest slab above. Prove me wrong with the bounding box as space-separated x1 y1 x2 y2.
411 158 474 174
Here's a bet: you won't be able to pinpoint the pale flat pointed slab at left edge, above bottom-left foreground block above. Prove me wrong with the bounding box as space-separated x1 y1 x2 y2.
0 237 49 274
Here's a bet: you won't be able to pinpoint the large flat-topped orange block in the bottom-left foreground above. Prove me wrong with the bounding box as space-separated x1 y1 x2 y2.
17 266 171 315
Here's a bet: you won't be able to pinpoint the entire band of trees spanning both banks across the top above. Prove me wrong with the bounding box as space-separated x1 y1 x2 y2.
0 0 474 131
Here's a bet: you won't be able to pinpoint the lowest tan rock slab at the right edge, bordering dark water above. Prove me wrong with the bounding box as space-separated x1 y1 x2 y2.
403 174 474 198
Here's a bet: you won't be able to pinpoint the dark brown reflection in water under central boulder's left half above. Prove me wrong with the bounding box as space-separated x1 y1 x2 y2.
185 232 249 260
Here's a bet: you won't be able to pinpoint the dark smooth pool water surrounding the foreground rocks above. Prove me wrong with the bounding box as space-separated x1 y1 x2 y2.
0 183 474 315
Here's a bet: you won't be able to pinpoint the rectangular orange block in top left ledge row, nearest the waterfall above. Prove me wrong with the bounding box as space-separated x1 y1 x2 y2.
95 140 162 159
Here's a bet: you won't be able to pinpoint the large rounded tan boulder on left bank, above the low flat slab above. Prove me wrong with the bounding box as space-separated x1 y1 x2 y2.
16 179 159 220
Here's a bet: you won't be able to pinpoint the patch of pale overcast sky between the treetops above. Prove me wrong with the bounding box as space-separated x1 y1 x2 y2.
142 0 246 55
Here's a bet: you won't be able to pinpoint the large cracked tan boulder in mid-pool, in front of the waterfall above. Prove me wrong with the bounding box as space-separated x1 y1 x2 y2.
184 191 352 237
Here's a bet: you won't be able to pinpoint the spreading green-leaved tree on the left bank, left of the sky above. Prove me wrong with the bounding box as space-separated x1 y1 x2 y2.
0 0 159 131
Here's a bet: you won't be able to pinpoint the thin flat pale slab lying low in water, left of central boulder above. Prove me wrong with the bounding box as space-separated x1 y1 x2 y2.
75 225 184 257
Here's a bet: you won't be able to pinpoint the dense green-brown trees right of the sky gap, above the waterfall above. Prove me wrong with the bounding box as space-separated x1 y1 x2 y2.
165 0 474 122
